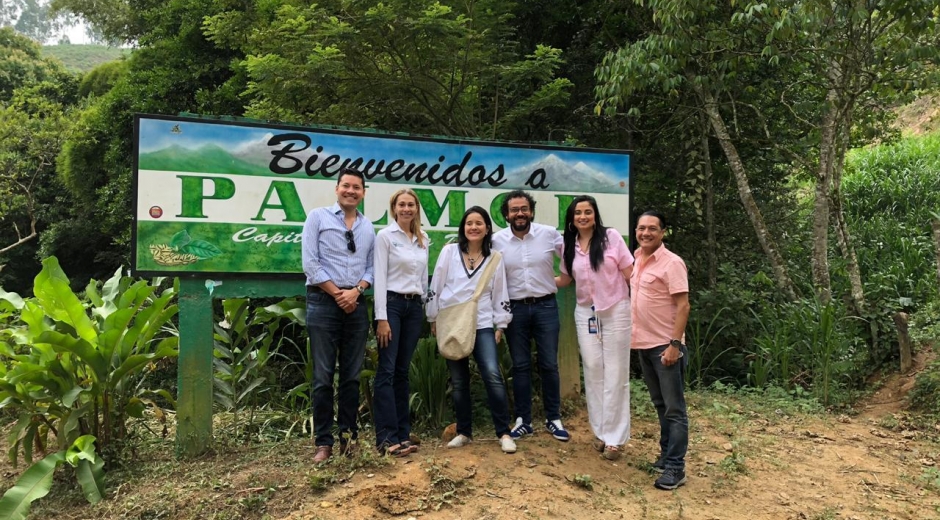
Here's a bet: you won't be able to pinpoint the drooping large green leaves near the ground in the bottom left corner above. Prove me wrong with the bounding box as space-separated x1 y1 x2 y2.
0 435 104 520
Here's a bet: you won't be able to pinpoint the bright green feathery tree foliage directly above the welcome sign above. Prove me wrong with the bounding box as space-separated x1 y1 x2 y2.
203 0 572 138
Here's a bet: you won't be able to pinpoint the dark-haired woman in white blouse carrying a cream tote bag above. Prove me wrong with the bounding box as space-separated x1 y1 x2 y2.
427 206 516 453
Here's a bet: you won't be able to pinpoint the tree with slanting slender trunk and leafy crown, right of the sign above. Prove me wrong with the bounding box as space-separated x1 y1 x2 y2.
597 0 796 299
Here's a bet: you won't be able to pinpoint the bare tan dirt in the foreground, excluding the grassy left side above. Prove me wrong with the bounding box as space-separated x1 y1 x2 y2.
283 390 940 520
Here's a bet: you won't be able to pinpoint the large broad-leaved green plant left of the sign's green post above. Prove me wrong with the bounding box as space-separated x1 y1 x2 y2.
0 258 179 464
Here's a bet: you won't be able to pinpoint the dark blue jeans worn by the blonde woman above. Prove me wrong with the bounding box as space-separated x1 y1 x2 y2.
372 295 424 446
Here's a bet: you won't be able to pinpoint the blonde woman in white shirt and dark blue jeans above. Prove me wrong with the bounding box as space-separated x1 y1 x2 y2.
373 189 428 457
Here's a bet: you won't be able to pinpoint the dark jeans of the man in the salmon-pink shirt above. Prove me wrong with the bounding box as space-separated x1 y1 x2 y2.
637 345 689 470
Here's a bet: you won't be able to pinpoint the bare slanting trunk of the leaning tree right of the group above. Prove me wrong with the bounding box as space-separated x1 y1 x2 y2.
695 85 796 300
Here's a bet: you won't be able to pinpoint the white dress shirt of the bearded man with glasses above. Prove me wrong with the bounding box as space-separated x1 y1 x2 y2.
493 222 564 300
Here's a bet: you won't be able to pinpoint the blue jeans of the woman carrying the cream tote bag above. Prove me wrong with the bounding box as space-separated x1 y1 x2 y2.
447 327 509 438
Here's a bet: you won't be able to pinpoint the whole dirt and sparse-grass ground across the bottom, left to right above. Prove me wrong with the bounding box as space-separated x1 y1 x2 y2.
7 352 940 520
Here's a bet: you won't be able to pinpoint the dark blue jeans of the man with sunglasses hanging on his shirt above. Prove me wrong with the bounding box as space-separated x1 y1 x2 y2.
307 287 369 446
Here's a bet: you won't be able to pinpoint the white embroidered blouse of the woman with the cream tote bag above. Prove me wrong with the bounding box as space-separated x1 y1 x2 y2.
427 244 512 329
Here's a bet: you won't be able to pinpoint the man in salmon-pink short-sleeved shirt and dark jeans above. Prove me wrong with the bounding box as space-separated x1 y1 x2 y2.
630 211 689 490
